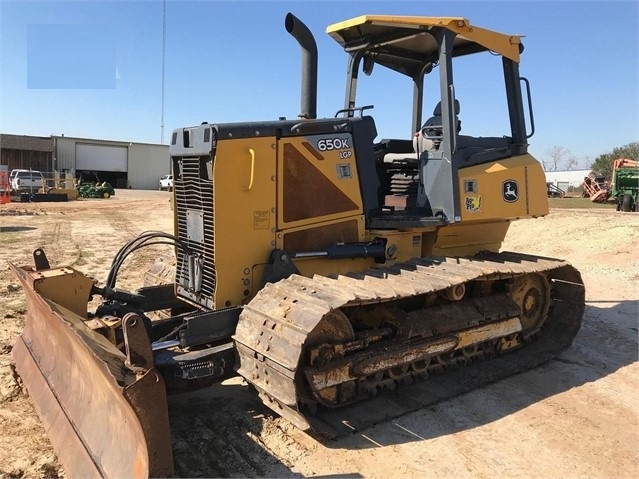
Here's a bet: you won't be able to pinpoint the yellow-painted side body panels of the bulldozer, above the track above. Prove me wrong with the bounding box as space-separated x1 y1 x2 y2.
204 137 548 308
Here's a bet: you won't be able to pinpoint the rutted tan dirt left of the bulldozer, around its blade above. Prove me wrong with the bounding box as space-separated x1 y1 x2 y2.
0 192 172 478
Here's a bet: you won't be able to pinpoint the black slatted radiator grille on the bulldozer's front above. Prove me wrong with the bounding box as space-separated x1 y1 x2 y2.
173 156 215 308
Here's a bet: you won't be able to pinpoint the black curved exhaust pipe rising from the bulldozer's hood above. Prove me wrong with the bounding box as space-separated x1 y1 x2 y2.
284 13 317 119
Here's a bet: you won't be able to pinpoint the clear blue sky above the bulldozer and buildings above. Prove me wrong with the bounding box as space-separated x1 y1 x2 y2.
0 0 639 167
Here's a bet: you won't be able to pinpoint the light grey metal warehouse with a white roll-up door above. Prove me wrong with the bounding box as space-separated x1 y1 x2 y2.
53 136 170 190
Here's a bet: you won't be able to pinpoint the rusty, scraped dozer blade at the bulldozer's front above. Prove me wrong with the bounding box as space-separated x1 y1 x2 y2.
10 265 173 477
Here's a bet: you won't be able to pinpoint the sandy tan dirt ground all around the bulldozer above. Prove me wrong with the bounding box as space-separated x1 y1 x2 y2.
0 190 639 478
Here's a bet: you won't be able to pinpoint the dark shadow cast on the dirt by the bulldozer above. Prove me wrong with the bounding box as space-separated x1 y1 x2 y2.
169 301 639 477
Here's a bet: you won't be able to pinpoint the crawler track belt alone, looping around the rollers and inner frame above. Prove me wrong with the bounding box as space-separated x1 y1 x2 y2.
234 252 585 436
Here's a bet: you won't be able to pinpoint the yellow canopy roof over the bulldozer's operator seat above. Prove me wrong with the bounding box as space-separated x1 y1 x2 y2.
326 15 522 77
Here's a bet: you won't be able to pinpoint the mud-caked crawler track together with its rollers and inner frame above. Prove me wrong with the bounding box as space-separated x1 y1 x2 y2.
234 253 584 435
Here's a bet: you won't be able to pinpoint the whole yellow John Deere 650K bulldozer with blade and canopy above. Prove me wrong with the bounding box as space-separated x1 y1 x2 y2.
11 13 585 477
